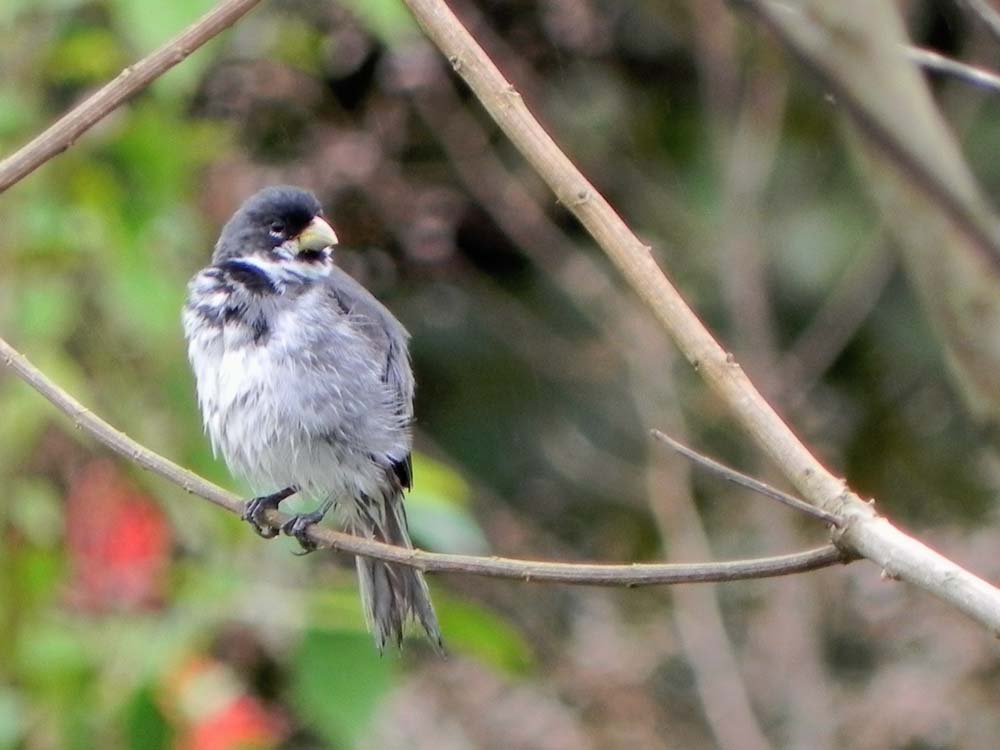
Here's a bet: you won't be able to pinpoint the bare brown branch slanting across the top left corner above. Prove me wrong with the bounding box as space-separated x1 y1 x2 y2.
0 0 261 193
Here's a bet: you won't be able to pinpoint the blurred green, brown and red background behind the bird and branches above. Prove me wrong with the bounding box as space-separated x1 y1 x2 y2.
0 0 1000 750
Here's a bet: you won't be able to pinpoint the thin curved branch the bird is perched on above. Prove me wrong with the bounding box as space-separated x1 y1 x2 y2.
0 339 850 587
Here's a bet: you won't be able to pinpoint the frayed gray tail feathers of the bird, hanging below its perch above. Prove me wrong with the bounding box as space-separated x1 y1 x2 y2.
349 494 443 651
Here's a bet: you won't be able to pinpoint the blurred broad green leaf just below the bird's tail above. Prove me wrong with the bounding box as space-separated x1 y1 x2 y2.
292 630 396 747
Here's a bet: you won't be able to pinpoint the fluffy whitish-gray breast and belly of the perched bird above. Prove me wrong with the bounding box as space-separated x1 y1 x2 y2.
185 274 409 502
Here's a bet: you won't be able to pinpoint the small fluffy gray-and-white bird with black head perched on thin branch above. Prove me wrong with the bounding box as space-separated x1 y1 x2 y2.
184 186 441 650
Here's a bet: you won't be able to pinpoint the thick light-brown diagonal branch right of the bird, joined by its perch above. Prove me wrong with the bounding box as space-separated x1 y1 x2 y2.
405 0 1000 634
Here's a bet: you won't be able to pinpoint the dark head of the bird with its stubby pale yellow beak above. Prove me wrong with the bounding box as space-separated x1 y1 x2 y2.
212 185 337 270
